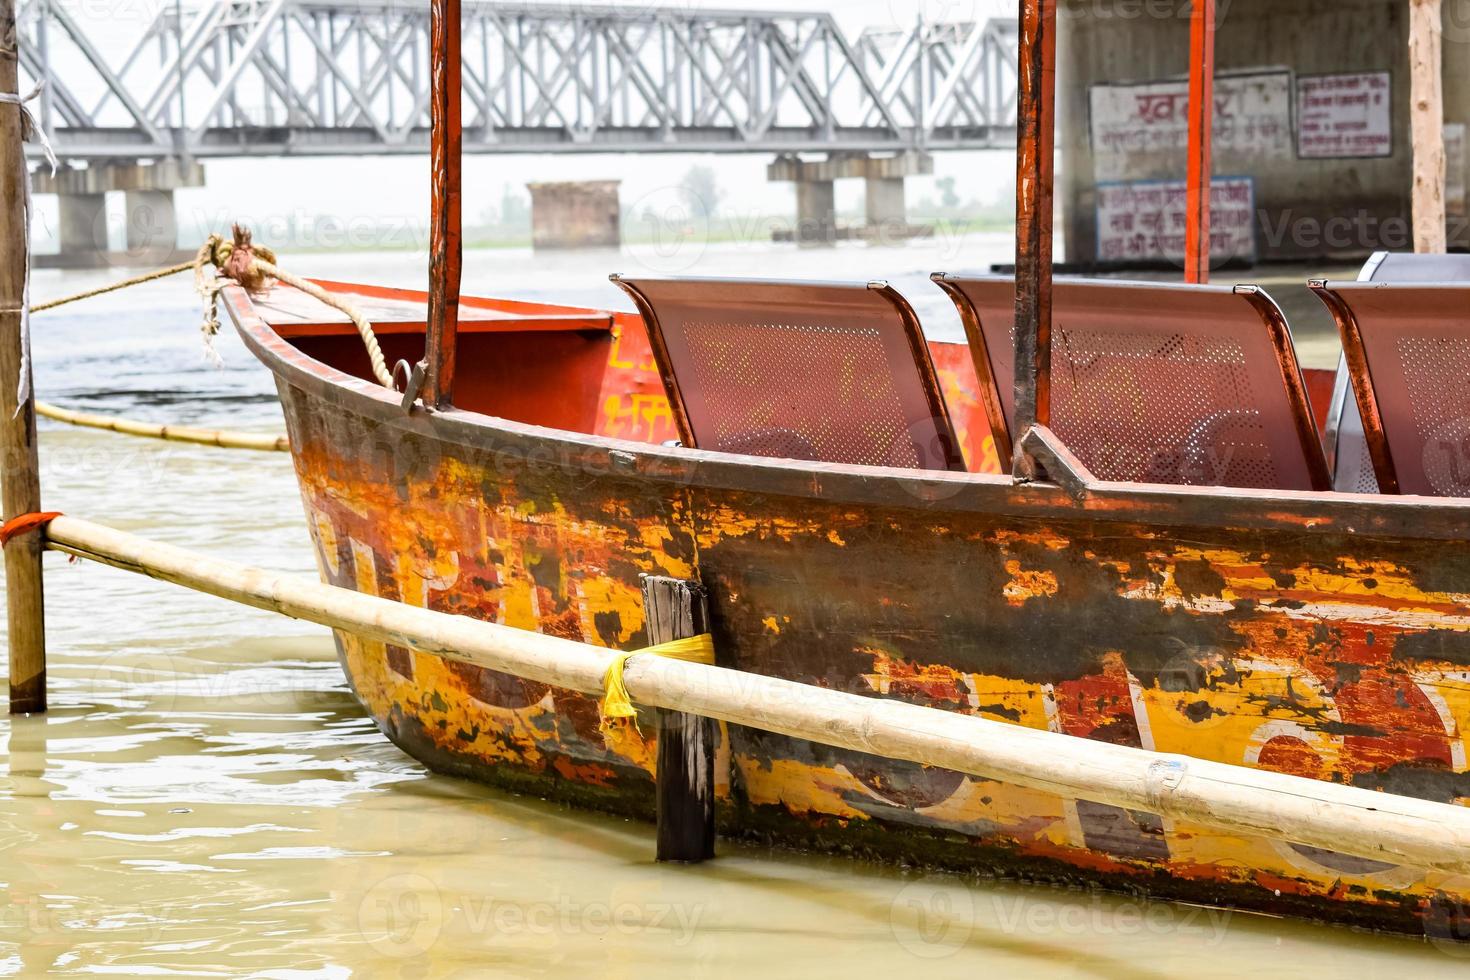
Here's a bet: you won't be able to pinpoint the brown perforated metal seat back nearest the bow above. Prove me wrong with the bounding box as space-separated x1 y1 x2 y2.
613 276 964 472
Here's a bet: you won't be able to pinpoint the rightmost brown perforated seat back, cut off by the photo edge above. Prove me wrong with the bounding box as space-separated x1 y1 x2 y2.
1317 282 1470 497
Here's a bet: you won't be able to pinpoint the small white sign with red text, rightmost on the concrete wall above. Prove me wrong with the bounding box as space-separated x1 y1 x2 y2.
1297 72 1394 160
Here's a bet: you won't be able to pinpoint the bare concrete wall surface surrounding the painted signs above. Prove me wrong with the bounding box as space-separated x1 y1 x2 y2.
1057 0 1470 263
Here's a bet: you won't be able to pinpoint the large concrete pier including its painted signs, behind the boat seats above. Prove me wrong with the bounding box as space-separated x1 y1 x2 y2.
1057 0 1470 264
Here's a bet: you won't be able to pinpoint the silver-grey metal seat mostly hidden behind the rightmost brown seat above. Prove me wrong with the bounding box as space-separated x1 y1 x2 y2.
1324 251 1470 494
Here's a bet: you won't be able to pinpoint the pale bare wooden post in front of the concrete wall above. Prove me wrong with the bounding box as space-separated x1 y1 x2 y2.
1408 0 1446 253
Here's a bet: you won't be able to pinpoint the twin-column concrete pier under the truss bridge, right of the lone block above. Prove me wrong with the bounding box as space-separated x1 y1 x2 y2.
766 151 933 245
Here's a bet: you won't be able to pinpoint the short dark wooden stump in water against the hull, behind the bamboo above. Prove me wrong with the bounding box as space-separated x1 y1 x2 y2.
644 576 714 861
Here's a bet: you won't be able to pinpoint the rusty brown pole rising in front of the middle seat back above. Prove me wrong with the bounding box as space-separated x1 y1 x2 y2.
1013 0 1057 479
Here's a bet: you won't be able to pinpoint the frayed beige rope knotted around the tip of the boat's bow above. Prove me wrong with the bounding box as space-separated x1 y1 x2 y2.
194 225 395 388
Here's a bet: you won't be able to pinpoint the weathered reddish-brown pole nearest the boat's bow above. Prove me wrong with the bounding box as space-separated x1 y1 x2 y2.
423 0 463 408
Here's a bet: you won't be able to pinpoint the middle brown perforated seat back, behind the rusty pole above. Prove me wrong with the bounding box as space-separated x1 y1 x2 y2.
933 273 1329 489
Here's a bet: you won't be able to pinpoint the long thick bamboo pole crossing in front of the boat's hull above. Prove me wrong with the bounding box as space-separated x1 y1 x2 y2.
37 517 1470 874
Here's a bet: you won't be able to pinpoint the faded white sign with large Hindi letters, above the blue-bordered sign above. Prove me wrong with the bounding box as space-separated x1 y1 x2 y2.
1088 72 1294 182
